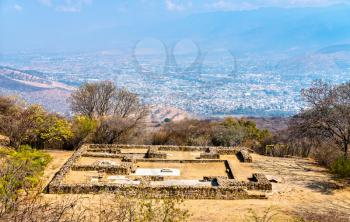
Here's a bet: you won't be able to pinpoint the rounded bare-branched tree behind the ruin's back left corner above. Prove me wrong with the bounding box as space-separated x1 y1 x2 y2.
71 82 148 143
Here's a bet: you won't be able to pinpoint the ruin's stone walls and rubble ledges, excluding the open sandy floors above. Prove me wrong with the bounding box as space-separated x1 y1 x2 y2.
45 144 272 199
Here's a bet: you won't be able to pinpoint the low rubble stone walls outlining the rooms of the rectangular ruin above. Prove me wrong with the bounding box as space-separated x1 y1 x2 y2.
46 145 272 200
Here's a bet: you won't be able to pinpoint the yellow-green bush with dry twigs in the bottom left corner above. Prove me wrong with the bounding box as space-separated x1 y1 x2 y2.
0 148 85 222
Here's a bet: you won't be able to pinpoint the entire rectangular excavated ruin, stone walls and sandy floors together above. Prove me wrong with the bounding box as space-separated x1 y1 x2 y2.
45 144 272 200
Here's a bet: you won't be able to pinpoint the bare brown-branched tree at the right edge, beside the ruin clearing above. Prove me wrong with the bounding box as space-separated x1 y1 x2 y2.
289 81 350 158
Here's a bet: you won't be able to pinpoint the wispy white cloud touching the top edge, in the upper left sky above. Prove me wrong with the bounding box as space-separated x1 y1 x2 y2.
38 0 92 12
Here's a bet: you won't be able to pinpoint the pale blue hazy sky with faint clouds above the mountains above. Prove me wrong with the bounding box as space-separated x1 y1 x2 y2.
0 0 350 52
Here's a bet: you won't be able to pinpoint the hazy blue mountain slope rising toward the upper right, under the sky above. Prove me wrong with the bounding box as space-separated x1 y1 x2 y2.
129 5 350 53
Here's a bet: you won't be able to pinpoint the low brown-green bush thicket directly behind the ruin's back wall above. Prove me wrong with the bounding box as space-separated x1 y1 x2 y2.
152 118 270 148
